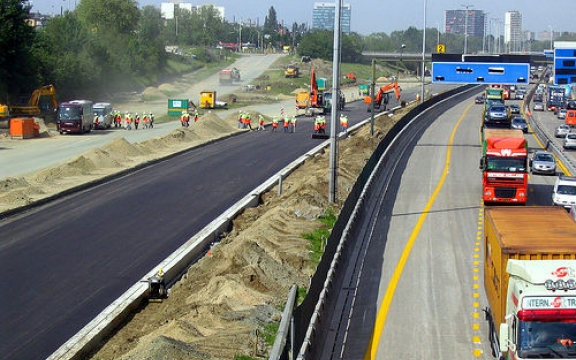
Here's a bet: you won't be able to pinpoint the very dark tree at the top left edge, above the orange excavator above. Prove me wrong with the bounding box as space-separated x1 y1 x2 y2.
0 0 39 101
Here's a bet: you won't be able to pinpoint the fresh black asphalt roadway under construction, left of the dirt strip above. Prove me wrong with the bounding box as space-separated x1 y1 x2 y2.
0 95 418 360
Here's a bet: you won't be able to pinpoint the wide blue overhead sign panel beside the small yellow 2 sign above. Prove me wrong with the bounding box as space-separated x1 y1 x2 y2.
432 62 530 84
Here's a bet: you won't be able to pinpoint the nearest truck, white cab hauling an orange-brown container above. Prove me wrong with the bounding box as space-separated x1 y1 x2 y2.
483 206 576 360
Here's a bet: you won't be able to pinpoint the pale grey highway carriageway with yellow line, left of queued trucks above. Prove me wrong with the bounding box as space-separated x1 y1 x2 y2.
322 88 573 360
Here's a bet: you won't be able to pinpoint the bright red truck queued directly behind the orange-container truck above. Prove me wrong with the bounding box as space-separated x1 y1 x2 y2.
480 128 528 205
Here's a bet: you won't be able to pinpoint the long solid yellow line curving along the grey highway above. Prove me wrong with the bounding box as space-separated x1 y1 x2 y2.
364 103 474 360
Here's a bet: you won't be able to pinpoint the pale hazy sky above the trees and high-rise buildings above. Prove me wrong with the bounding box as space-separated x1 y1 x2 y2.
30 0 576 35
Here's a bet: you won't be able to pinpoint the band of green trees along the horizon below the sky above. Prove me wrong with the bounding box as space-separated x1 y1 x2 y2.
0 0 574 103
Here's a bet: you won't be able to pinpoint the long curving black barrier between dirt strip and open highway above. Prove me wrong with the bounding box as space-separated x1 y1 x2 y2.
283 85 479 359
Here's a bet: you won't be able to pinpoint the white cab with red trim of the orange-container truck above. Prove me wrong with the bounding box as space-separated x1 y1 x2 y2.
499 259 576 359
